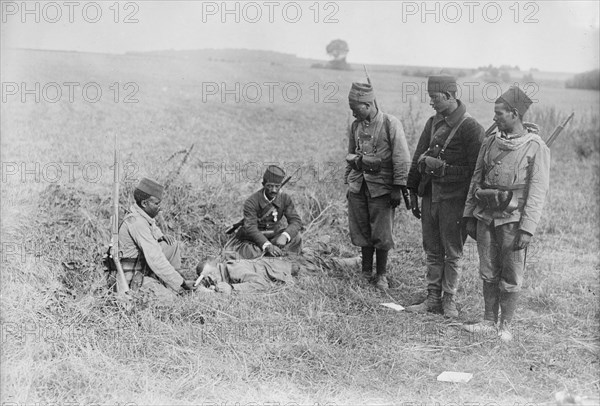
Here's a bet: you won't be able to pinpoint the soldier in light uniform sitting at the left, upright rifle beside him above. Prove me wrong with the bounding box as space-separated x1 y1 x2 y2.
119 178 194 301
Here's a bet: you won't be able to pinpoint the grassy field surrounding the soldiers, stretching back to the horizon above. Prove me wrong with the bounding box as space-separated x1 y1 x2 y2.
0 51 600 405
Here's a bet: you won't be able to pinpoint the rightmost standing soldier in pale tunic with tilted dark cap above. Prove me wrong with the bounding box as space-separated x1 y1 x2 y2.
464 87 550 341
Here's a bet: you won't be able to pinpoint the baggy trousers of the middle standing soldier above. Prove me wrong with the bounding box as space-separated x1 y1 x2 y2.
421 195 466 295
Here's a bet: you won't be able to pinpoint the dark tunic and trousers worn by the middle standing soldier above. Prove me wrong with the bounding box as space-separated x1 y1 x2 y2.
407 100 485 294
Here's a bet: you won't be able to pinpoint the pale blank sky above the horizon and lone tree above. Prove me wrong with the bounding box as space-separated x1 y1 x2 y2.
1 0 600 73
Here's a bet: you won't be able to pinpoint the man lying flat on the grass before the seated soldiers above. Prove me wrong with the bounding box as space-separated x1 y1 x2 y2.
195 255 360 294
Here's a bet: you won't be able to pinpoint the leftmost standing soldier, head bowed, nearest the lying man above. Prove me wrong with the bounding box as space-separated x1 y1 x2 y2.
344 83 410 290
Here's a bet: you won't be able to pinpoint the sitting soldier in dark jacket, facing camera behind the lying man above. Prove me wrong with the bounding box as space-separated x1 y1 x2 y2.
223 165 302 259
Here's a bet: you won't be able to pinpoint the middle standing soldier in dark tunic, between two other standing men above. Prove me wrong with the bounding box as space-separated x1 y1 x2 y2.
406 75 484 317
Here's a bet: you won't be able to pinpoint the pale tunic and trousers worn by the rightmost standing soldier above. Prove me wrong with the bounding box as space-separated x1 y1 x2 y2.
464 124 550 292
